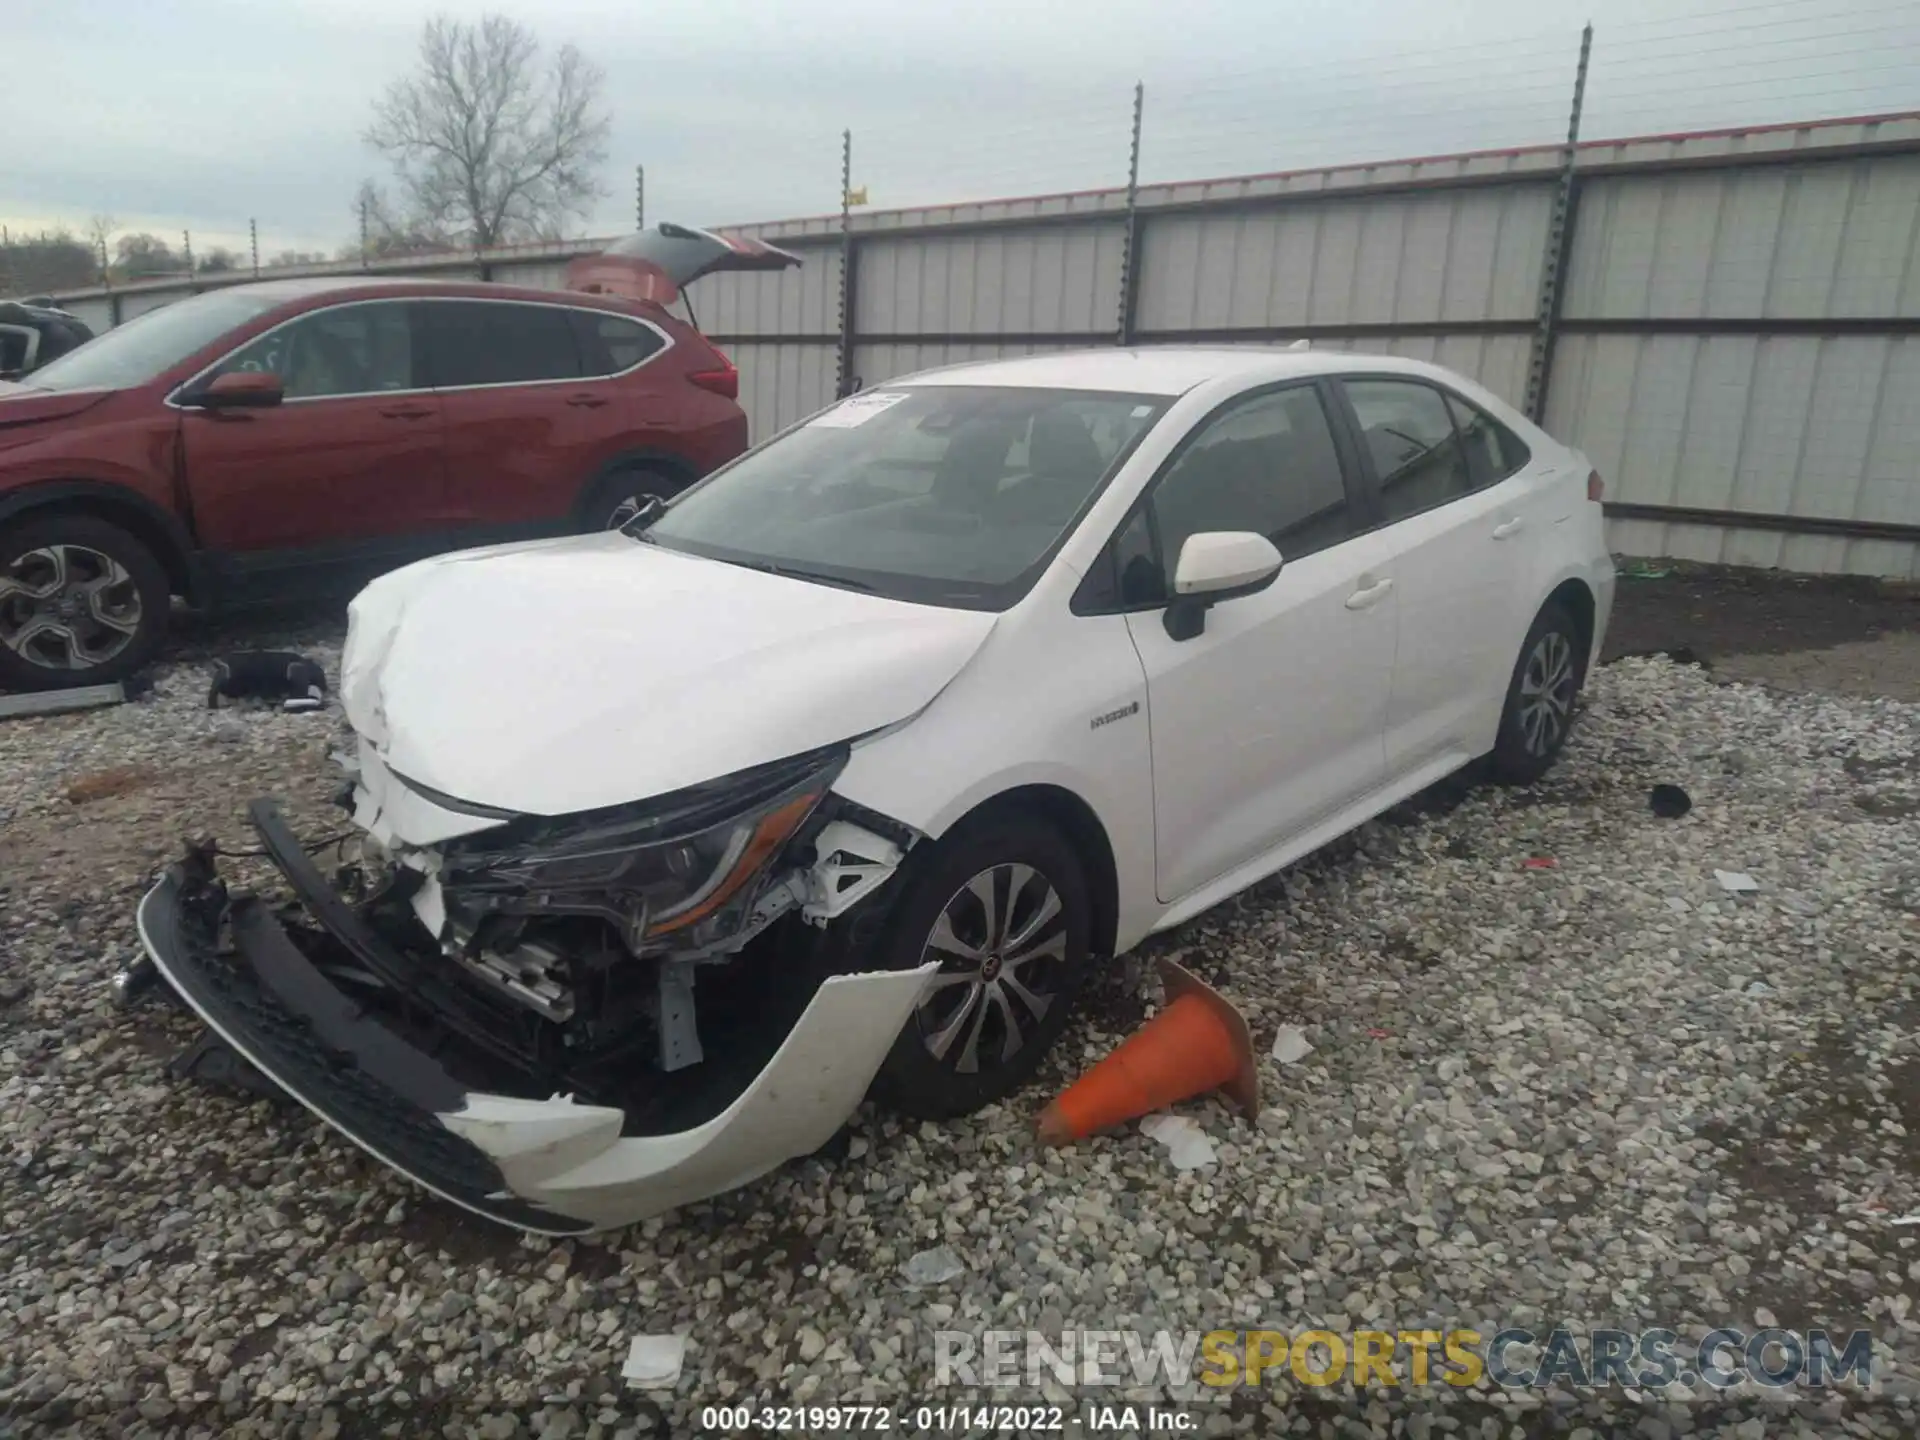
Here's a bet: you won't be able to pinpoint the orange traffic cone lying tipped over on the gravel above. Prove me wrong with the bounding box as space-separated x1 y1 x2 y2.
1039 960 1260 1144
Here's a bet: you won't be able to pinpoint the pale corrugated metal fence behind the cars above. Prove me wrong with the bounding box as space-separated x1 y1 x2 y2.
37 115 1920 576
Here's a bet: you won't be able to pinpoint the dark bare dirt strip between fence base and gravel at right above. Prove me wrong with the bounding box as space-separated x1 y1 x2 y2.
1601 561 1920 703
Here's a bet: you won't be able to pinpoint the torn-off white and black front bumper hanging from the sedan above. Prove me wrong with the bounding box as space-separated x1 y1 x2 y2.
138 803 937 1235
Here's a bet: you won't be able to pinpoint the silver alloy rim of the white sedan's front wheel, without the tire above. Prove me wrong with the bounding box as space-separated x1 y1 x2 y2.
916 864 1068 1075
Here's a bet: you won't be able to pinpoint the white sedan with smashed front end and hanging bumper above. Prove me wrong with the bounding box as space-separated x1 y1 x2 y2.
140 349 1613 1231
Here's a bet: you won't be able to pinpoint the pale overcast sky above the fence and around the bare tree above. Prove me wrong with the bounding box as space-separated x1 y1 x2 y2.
11 0 1920 255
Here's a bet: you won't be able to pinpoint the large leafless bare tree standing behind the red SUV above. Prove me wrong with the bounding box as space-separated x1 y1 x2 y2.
367 15 609 248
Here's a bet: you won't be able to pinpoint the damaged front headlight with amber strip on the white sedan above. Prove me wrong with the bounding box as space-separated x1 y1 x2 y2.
440 747 847 945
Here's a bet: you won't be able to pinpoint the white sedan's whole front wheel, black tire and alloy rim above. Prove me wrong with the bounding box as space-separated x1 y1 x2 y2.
872 812 1092 1119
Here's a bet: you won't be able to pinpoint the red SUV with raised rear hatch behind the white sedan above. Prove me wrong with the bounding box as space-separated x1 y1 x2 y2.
0 225 799 689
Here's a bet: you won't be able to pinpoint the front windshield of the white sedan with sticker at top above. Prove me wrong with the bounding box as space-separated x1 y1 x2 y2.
645 386 1167 611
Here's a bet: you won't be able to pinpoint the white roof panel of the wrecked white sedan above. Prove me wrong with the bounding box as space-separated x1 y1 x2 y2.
891 346 1432 396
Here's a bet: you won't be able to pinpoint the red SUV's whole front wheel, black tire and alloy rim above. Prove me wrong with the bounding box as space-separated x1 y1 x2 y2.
0 513 171 691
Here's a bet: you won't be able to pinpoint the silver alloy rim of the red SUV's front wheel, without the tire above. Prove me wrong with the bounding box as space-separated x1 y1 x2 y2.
0 543 142 670
